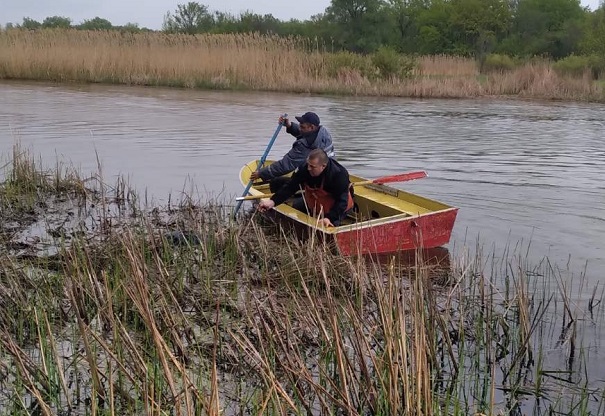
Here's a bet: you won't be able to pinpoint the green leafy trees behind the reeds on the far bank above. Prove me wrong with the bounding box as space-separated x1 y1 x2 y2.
7 0 605 61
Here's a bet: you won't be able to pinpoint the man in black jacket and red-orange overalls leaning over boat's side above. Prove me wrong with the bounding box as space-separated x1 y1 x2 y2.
258 149 353 227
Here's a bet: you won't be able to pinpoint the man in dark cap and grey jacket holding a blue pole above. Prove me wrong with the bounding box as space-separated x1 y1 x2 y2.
250 112 335 192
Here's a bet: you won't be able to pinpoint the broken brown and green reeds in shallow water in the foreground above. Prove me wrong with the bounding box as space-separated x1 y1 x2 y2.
0 148 605 415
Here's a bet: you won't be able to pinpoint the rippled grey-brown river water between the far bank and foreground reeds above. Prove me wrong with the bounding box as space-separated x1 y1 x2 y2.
0 83 605 286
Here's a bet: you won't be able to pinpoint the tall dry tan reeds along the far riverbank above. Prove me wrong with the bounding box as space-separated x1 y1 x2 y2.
0 30 605 102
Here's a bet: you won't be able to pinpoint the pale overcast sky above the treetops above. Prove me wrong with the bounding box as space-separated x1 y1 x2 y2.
0 0 599 29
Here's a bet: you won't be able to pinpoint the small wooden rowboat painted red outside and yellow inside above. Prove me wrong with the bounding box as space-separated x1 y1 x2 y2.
240 160 458 255
